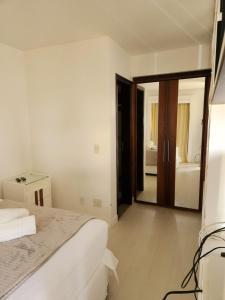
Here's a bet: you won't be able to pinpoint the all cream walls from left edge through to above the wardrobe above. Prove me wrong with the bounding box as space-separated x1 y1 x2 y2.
0 37 211 222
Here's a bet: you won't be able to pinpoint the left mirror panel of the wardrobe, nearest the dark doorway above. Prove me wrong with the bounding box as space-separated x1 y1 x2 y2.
137 82 159 203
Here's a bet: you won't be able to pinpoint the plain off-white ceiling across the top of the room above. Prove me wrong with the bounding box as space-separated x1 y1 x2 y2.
0 0 215 54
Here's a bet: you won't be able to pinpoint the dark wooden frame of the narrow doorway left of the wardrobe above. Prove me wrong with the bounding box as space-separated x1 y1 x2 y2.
115 73 133 212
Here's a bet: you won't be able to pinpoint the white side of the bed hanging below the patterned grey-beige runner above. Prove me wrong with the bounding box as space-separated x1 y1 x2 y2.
7 219 108 300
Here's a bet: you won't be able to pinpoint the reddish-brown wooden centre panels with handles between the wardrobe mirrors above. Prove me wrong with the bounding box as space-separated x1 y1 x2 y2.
157 80 178 206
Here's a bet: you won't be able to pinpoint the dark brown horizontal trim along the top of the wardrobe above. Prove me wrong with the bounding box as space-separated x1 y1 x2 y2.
133 69 211 84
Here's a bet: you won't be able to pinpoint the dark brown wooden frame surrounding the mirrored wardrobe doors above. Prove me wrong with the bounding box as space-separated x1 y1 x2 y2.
131 69 211 212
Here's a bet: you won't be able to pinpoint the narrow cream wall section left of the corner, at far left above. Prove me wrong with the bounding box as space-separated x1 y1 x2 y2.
0 44 31 197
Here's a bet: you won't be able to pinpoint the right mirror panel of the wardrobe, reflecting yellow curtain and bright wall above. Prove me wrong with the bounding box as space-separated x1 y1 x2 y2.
175 78 205 209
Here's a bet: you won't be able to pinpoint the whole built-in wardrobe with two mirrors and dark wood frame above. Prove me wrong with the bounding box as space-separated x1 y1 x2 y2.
134 70 211 211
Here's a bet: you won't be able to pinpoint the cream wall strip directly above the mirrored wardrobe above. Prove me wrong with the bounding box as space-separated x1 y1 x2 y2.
131 45 210 77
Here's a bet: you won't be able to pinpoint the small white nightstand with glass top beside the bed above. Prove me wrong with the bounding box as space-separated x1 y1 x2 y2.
3 172 52 207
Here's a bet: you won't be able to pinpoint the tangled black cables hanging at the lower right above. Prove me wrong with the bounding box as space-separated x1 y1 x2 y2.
163 227 225 300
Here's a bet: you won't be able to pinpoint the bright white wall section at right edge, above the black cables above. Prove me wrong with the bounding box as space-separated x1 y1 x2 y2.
203 105 225 225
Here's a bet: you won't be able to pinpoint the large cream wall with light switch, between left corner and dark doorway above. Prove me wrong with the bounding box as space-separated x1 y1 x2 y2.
26 37 130 222
